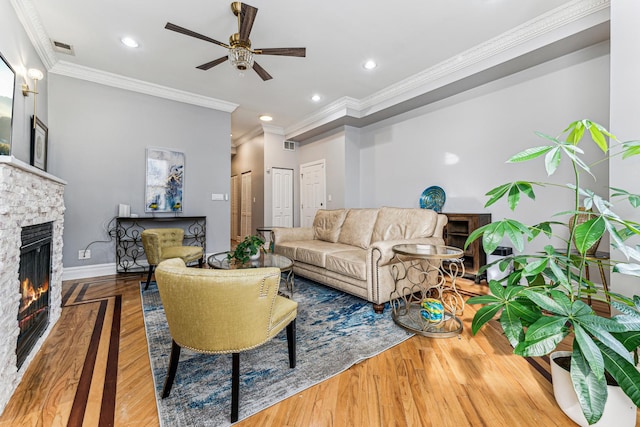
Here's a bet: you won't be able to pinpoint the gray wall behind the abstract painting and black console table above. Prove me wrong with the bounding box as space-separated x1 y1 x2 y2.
49 74 231 267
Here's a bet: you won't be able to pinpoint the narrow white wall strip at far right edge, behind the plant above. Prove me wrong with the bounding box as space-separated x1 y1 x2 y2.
609 0 640 296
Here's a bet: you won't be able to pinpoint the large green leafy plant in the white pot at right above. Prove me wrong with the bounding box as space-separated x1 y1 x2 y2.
465 120 640 424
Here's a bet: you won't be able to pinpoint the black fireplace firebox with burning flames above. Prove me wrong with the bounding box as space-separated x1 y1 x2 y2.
16 222 53 369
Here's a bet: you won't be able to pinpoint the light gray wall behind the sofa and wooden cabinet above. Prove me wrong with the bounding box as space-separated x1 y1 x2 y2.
360 44 609 254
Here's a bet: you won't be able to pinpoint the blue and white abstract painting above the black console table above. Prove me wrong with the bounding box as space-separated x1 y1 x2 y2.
144 148 184 212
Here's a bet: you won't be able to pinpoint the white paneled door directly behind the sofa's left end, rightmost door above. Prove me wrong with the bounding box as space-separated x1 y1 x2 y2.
300 159 327 227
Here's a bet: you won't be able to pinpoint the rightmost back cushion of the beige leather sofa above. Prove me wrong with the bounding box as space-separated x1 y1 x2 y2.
371 206 438 242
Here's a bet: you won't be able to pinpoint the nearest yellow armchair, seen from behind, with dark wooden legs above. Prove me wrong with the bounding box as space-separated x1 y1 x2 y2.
156 259 298 422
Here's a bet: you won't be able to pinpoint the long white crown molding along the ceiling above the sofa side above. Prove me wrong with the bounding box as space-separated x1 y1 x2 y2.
285 0 610 139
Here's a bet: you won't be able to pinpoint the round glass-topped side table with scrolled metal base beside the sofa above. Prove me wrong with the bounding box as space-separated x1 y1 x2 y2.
390 244 465 338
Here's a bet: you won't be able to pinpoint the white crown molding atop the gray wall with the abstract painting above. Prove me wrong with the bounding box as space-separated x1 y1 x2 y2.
49 61 238 113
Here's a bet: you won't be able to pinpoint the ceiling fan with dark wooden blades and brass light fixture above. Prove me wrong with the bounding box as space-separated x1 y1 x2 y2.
165 1 307 81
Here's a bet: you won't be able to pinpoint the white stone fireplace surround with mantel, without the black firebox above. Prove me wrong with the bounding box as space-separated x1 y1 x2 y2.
0 156 66 413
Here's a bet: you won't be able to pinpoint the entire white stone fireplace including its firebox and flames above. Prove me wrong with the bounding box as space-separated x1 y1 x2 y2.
0 156 65 413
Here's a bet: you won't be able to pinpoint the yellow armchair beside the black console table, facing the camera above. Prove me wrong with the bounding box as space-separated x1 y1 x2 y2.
141 228 204 291
